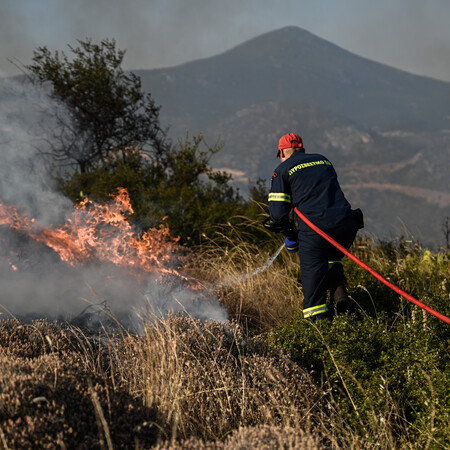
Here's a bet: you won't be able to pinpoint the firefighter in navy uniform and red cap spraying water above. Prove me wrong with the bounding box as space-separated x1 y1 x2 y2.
266 133 363 321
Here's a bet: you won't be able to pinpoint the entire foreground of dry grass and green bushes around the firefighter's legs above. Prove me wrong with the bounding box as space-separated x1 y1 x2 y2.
0 232 450 448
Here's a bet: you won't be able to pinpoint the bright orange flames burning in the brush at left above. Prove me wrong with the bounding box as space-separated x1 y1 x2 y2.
0 188 178 273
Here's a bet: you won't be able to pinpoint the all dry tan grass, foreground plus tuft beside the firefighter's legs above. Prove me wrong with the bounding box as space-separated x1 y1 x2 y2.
0 232 442 450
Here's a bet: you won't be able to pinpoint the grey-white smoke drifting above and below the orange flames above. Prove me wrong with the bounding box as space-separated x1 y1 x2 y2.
0 79 227 330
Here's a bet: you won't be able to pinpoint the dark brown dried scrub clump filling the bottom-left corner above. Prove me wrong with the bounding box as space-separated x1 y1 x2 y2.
0 320 161 449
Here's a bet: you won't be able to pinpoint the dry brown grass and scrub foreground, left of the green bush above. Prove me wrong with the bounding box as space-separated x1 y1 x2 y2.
0 316 321 449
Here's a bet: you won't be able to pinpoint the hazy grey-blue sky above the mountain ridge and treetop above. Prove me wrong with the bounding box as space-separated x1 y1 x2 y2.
0 0 450 81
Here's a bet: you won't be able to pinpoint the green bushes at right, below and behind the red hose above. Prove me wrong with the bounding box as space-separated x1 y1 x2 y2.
270 242 450 448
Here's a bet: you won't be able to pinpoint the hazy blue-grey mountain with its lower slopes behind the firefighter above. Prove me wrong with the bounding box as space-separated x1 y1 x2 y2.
136 27 450 245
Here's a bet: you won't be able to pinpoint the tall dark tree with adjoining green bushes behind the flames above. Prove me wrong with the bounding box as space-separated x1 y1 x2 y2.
27 40 268 244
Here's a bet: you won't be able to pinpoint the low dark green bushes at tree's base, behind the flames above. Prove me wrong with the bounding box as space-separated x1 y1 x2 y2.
60 135 265 245
